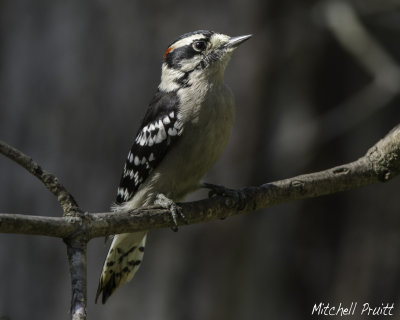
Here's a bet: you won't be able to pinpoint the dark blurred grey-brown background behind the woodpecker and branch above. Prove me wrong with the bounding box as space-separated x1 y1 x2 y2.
0 0 400 320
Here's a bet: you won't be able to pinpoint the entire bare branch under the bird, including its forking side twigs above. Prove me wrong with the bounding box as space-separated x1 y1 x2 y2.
0 125 400 320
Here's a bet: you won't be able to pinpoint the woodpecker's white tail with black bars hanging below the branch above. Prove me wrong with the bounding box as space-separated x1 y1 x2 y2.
96 232 147 304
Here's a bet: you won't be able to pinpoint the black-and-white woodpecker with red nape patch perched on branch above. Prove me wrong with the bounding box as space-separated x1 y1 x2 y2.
96 30 252 304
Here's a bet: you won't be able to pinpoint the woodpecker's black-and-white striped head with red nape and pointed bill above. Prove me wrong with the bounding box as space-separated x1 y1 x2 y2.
159 30 251 91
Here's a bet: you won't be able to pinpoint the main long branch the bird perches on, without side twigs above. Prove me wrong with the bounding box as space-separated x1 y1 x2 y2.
0 125 400 239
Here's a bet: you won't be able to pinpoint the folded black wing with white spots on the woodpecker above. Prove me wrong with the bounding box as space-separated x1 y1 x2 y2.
116 91 183 205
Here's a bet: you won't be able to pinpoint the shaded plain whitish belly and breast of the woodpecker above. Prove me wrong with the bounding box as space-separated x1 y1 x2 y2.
134 86 235 206
